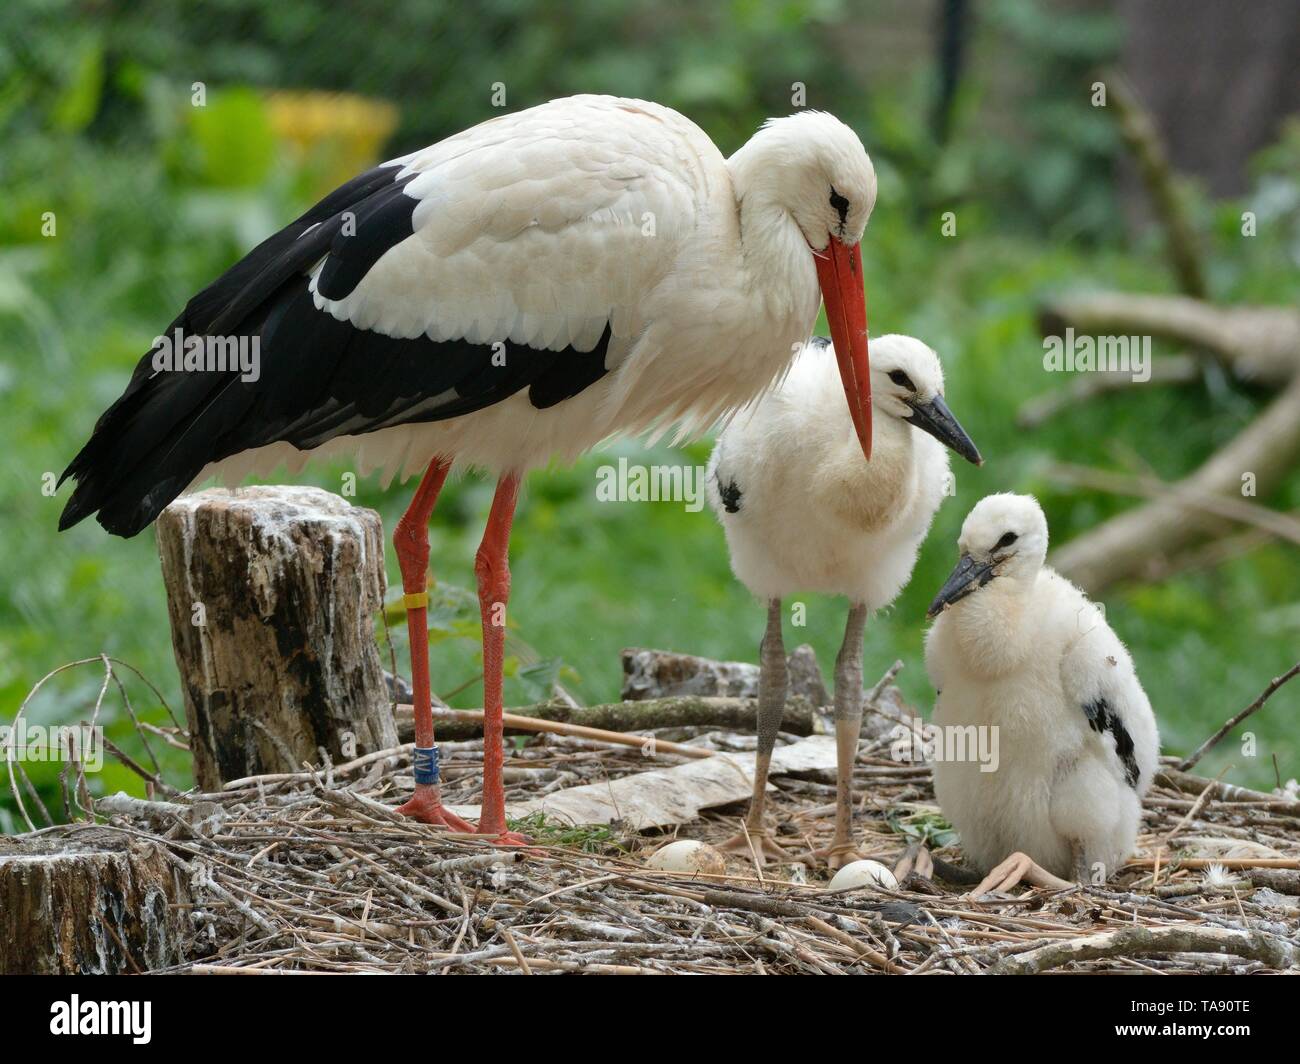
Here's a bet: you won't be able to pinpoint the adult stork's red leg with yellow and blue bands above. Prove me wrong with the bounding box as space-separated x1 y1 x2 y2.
393 458 473 832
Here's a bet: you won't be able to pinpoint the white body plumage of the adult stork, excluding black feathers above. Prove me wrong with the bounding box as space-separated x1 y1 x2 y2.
196 96 876 483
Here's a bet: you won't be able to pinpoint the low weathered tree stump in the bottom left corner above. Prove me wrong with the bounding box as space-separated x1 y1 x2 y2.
0 829 189 976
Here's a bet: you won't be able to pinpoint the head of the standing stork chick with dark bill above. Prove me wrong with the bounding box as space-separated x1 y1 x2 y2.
871 333 984 466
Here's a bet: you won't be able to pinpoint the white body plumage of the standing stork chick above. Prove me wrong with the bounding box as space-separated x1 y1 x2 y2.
706 336 950 610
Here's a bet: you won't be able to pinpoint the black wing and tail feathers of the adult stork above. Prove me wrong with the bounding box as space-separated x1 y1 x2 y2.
59 165 611 536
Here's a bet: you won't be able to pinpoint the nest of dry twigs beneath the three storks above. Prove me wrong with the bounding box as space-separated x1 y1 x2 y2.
12 707 1300 974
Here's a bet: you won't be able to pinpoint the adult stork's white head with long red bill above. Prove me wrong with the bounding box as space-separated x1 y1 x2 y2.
729 111 876 458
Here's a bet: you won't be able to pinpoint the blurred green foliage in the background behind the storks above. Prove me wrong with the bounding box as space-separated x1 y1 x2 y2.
0 0 1300 830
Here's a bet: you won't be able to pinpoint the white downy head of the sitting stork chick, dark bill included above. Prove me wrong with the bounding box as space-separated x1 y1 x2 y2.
926 494 1048 617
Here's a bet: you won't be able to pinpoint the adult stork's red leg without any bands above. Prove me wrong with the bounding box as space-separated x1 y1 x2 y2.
475 473 528 845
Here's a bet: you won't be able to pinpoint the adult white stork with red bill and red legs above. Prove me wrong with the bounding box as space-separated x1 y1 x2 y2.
60 96 876 842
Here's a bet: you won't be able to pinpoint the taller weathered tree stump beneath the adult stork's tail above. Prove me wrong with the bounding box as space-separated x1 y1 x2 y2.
157 486 397 791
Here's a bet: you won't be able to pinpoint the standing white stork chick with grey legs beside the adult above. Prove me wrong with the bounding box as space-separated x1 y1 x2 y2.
706 336 982 868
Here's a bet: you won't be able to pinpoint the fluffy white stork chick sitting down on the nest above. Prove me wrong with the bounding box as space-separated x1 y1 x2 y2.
926 494 1160 894
